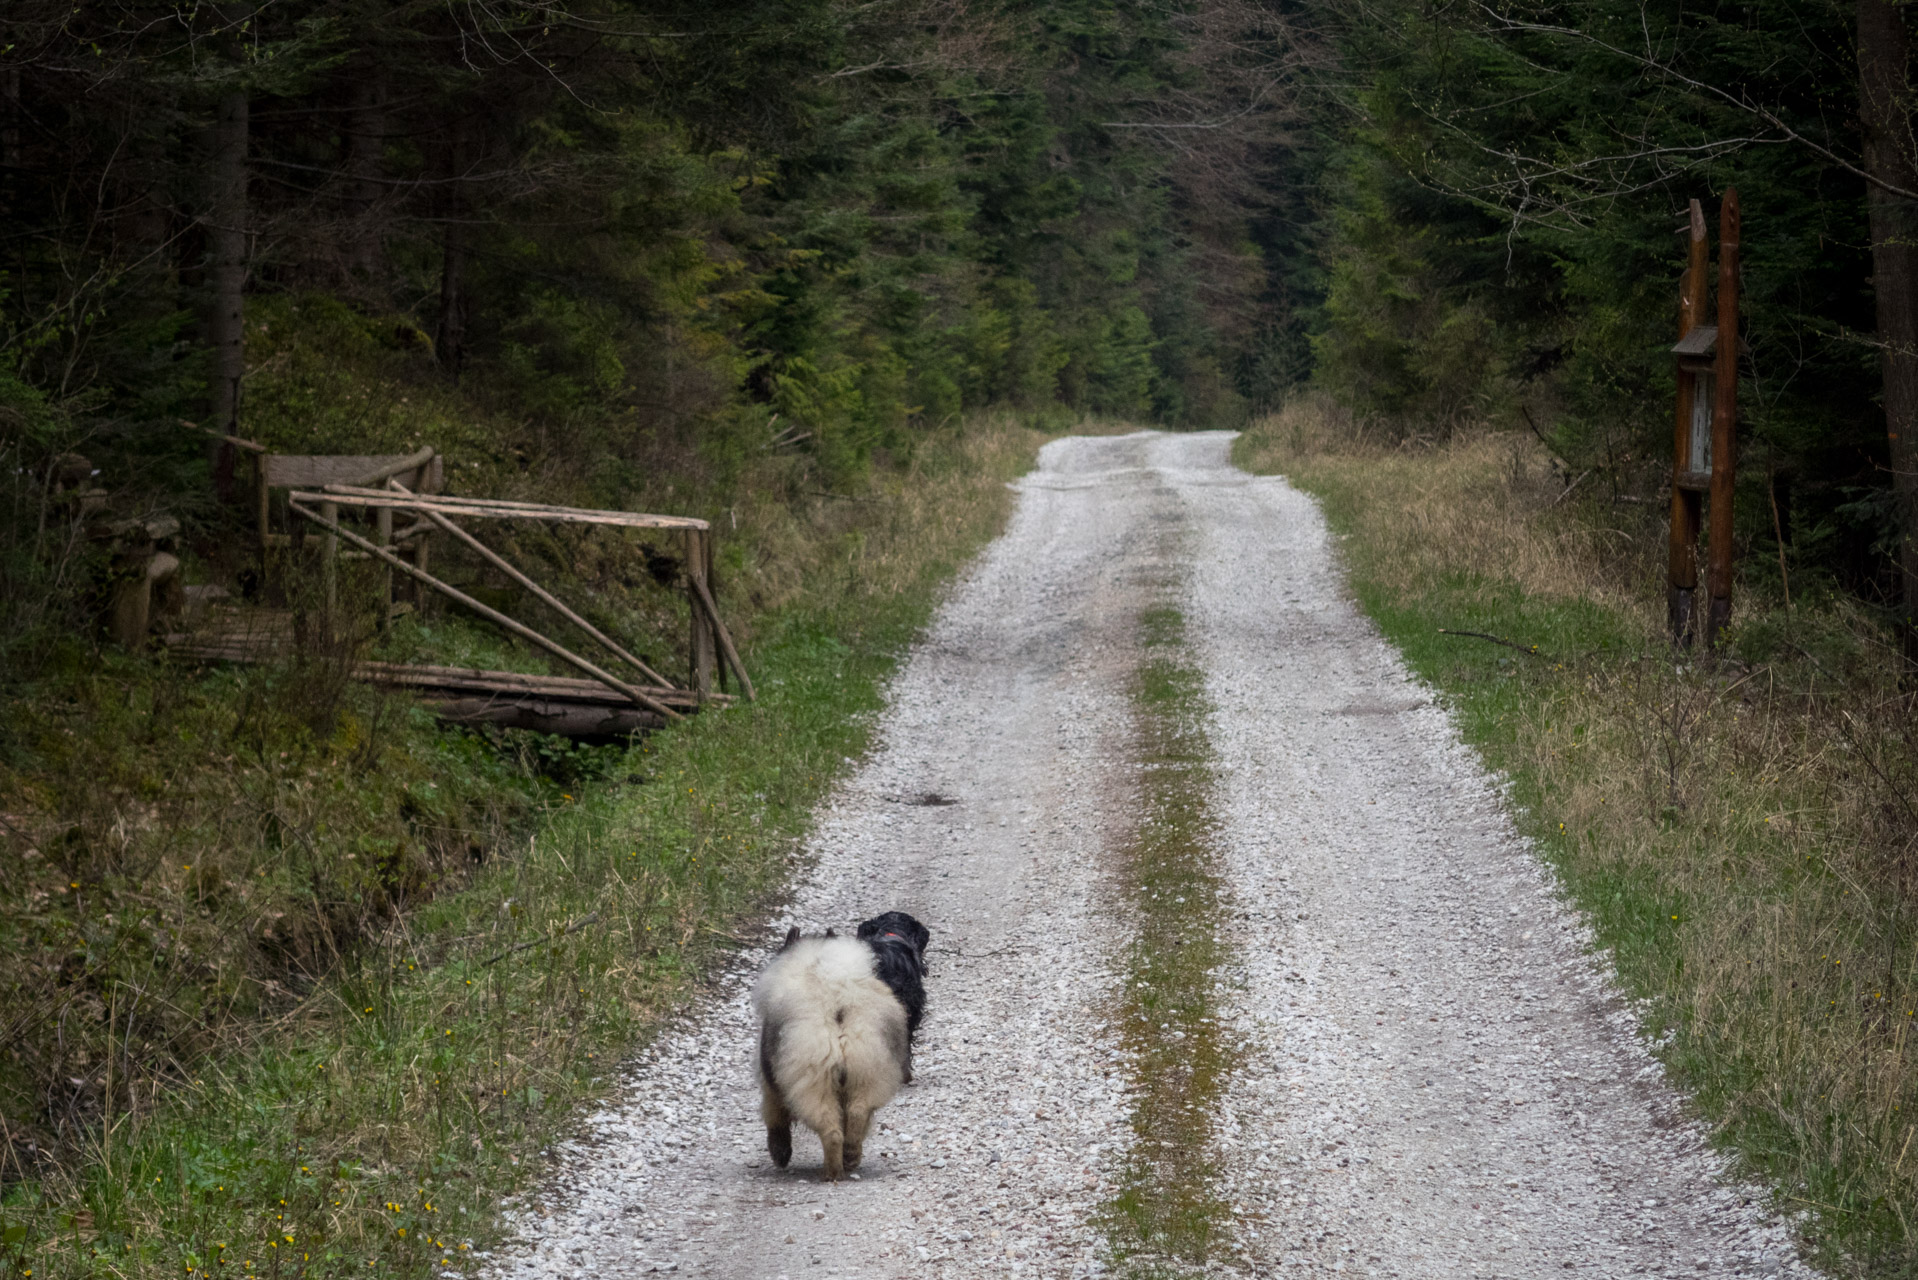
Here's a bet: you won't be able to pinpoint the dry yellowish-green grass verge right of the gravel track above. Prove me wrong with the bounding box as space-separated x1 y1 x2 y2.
1237 399 1918 1276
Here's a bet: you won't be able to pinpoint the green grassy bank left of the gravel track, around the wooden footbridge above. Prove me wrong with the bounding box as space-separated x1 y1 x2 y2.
0 420 1040 1276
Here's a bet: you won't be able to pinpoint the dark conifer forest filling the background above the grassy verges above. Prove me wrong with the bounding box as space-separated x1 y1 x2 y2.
0 0 1918 652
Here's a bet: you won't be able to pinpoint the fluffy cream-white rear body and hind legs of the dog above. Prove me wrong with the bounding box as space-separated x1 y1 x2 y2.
752 938 907 1178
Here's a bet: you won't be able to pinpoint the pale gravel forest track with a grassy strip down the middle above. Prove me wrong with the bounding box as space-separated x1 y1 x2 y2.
487 432 1814 1280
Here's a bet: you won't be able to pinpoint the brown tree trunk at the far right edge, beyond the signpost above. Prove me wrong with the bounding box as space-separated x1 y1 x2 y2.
1859 0 1918 664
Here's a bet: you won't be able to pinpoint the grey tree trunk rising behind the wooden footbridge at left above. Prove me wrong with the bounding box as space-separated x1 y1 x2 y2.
207 88 247 497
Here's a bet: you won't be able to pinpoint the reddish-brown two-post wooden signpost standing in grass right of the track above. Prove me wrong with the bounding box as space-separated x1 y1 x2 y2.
1665 188 1740 649
